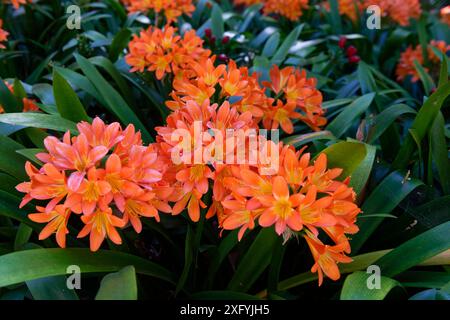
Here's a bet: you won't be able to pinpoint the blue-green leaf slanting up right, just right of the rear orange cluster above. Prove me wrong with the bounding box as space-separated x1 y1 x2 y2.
327 93 375 138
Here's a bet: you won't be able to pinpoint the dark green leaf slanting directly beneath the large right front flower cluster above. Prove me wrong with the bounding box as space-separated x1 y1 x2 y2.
227 228 278 292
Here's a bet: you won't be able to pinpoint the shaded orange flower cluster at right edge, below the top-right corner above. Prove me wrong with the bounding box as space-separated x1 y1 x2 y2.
395 40 450 82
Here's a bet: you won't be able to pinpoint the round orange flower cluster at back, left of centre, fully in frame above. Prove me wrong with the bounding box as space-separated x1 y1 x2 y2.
125 27 211 80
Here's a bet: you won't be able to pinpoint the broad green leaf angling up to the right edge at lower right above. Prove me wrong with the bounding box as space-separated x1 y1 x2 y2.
375 221 450 277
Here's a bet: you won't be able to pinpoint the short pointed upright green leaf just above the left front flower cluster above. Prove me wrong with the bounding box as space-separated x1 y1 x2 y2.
53 71 89 122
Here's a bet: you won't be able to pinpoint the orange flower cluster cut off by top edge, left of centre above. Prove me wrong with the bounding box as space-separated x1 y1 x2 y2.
122 0 195 24
